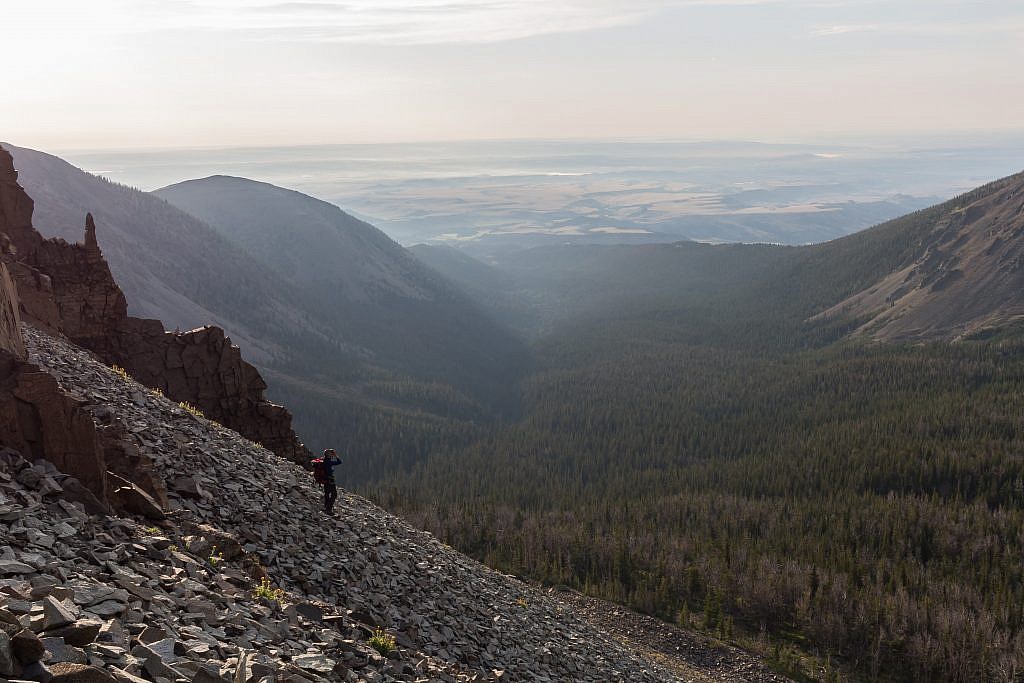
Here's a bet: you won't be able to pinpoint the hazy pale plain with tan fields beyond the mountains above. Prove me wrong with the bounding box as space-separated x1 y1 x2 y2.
62 135 1024 257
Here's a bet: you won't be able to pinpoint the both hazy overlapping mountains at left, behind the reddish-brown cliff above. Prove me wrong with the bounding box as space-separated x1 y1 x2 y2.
4 144 526 456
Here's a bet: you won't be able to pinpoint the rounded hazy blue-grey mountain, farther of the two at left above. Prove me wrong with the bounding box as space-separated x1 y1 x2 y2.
156 175 524 417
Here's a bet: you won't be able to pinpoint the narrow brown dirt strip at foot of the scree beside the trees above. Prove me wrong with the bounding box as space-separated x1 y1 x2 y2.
549 591 792 683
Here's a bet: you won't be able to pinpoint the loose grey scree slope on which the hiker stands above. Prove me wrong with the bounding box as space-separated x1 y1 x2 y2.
0 328 677 683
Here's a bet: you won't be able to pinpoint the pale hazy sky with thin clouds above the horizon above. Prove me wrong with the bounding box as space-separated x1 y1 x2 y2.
0 0 1024 151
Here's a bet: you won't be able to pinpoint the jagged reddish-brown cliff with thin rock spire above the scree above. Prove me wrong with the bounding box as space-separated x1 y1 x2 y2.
0 150 310 464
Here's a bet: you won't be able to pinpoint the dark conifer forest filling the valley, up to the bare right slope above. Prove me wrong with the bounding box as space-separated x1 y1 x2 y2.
315 174 1024 681
